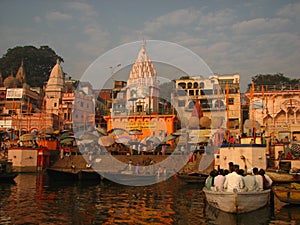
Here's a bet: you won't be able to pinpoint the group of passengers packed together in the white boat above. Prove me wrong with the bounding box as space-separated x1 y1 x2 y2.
205 162 273 192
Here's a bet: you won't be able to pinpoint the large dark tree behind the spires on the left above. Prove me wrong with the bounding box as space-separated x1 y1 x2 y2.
0 46 64 87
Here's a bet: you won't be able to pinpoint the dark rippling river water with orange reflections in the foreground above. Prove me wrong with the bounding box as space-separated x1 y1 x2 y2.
0 174 300 225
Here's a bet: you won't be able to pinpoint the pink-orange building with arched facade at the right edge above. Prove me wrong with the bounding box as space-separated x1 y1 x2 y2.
244 84 300 140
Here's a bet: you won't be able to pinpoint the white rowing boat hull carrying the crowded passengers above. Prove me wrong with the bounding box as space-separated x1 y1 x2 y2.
203 187 271 214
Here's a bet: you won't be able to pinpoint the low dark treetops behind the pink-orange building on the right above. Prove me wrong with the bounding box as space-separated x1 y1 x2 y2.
248 73 300 90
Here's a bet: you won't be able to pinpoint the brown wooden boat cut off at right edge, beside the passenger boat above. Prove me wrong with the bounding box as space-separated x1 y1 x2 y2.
273 186 300 205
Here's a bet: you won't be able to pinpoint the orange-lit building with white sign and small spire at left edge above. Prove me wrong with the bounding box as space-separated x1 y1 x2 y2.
0 62 44 135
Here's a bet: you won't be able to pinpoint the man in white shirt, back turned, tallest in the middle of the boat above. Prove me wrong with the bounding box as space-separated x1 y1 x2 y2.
224 165 245 192
